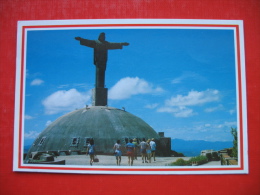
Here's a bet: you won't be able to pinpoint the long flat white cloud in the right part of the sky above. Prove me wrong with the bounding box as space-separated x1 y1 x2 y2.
165 89 220 106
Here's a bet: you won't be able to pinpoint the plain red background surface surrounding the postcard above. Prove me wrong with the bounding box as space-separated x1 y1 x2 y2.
0 0 260 195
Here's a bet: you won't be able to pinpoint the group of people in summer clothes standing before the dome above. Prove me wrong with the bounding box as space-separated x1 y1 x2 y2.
87 138 156 166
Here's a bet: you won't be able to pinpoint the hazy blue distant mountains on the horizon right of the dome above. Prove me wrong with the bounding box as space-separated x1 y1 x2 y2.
171 139 233 156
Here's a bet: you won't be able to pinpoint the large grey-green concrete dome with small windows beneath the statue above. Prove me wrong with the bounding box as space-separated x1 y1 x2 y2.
24 106 171 161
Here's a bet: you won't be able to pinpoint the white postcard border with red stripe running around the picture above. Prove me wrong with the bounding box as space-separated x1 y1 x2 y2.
13 19 248 175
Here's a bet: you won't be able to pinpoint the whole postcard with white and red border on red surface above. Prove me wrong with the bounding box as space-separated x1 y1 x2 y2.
13 19 248 174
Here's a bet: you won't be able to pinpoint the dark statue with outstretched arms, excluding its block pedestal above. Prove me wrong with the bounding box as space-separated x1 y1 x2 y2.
75 33 129 88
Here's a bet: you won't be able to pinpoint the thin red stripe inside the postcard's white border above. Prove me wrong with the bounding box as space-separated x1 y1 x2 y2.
18 24 244 174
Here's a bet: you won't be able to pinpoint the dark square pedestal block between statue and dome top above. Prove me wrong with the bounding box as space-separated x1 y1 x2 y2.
92 87 107 106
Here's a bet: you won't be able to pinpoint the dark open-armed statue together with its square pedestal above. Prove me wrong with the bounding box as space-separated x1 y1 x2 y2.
75 33 129 106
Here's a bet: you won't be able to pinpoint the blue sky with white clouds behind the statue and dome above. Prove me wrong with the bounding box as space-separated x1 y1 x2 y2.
24 29 237 143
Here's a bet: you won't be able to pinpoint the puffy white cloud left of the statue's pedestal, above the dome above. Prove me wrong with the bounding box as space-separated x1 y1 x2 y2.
42 89 90 114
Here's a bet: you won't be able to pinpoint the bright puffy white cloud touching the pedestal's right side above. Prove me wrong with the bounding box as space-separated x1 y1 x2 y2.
108 77 163 100
